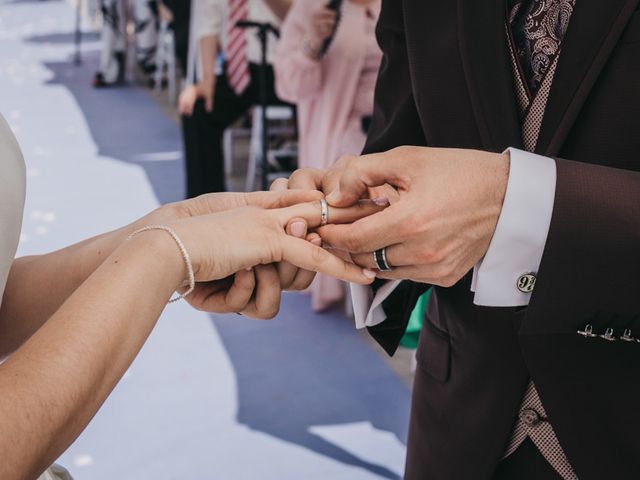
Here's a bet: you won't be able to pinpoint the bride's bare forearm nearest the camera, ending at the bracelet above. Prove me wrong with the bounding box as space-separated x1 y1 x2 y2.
0 232 185 479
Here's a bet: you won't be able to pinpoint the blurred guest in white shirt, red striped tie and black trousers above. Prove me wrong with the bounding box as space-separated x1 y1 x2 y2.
179 0 291 198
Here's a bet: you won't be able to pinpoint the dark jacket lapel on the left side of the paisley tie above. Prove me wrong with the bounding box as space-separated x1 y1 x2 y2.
457 0 524 151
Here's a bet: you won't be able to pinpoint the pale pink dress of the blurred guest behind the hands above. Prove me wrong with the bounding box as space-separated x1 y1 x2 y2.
274 0 382 311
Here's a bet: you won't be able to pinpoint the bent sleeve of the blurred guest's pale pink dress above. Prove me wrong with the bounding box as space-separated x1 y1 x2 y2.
274 0 322 103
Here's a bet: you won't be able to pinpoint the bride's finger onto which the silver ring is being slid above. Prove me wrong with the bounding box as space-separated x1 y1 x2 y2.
277 199 388 228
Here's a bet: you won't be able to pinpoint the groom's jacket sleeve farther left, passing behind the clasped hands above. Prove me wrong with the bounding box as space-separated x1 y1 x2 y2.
364 0 429 355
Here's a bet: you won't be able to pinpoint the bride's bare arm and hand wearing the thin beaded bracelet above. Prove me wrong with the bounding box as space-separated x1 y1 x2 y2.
0 202 375 480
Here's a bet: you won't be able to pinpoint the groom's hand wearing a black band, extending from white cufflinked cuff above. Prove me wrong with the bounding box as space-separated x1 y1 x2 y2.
319 147 509 286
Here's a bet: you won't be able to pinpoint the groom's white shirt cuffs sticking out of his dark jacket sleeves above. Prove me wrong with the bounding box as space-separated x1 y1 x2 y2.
351 148 556 328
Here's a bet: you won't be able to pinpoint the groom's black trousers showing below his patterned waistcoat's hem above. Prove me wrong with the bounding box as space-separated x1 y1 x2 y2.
492 438 562 480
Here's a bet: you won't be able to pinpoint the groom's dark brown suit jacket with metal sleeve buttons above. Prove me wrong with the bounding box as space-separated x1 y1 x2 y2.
365 0 640 480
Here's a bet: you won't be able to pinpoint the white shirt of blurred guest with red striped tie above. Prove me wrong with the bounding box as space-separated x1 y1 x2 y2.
187 0 281 80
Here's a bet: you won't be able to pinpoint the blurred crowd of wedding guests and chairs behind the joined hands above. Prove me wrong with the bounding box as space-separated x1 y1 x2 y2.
82 0 428 326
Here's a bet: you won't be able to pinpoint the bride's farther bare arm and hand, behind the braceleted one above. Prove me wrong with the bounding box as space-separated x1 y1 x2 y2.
0 191 317 358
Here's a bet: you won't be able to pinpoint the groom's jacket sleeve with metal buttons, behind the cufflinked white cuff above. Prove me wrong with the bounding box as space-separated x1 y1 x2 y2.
522 159 640 337
